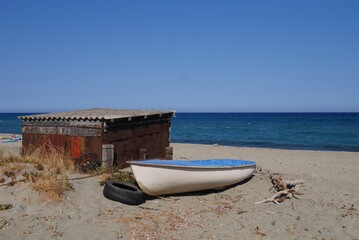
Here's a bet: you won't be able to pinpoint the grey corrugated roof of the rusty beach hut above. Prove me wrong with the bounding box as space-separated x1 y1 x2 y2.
19 108 175 121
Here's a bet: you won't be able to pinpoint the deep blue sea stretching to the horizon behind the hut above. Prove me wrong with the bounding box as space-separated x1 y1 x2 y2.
0 112 359 152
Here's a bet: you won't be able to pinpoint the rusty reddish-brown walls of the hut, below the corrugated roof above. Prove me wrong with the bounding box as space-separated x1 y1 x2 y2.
22 115 170 167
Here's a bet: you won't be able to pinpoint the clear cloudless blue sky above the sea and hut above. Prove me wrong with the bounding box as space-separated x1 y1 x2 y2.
0 0 359 112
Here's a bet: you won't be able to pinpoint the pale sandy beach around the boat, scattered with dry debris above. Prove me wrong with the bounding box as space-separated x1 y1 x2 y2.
0 142 359 240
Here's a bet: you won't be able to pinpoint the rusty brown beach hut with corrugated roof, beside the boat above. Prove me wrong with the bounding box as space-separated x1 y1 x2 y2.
19 108 175 167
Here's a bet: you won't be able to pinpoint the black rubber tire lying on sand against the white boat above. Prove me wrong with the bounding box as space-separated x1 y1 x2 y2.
103 181 146 205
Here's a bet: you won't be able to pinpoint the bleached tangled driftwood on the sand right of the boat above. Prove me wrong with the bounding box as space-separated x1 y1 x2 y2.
255 175 304 204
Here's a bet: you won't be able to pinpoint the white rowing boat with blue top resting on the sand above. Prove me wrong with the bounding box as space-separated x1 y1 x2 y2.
128 159 256 196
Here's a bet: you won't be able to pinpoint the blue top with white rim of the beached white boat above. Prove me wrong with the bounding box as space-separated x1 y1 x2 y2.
127 159 256 169
